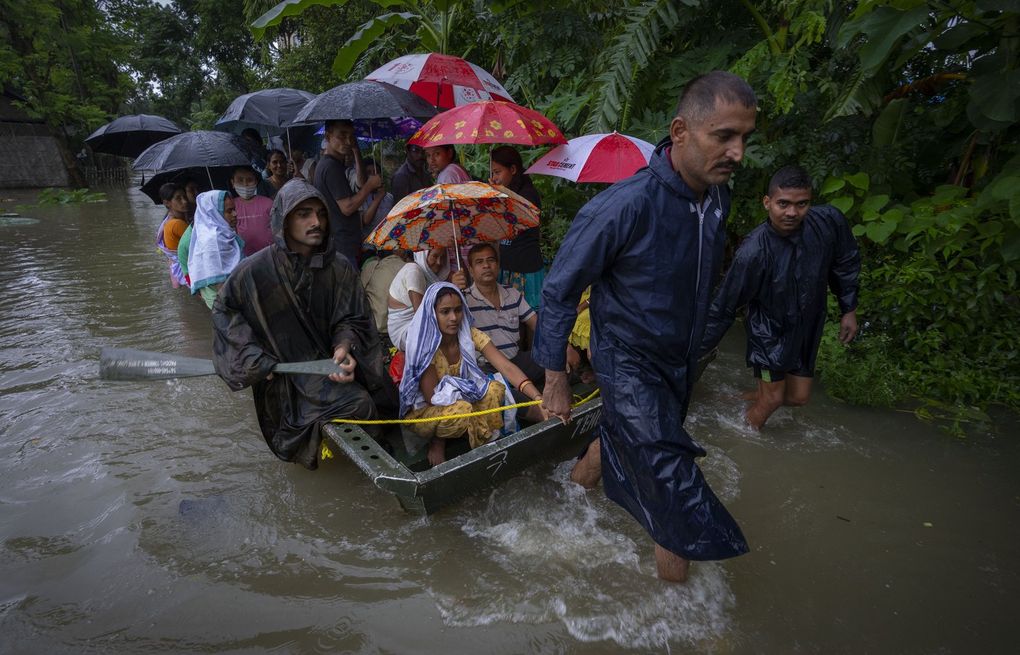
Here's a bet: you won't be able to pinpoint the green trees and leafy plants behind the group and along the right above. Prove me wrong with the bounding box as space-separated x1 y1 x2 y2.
0 0 1020 425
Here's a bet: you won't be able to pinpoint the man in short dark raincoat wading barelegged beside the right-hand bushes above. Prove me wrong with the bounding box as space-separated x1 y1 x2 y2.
702 166 861 430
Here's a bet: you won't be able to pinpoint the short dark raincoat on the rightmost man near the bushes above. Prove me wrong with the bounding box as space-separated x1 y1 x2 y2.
702 205 861 375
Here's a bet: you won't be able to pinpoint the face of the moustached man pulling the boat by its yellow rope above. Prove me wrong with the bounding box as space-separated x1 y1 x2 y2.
670 100 755 194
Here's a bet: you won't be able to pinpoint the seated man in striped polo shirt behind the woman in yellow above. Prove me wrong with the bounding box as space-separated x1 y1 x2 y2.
464 243 546 389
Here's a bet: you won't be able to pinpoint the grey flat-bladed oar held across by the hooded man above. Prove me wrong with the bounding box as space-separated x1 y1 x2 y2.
99 348 341 380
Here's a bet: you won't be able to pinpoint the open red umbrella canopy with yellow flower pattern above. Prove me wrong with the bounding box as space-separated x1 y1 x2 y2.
408 100 567 147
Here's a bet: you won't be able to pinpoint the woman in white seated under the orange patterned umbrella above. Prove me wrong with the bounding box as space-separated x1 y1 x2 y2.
387 248 467 350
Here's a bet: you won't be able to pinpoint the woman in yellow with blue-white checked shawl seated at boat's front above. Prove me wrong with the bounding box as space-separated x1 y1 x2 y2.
400 282 548 466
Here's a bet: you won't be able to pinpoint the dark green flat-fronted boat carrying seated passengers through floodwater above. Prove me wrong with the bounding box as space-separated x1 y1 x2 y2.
322 391 602 515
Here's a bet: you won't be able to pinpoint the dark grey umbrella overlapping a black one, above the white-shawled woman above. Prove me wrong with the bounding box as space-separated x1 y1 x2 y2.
134 130 259 170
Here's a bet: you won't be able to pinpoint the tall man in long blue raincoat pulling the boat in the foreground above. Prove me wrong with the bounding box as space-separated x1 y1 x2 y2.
532 71 757 582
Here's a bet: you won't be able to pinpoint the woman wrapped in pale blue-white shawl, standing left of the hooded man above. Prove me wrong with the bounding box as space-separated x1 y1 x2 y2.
188 191 245 309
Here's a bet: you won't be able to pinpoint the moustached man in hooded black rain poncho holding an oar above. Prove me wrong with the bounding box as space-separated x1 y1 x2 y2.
212 175 393 468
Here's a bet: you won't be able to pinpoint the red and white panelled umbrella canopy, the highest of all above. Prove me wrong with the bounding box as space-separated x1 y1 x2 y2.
365 52 513 109
